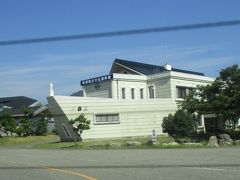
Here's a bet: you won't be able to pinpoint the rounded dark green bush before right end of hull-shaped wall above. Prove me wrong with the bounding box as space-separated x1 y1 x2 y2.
162 109 194 141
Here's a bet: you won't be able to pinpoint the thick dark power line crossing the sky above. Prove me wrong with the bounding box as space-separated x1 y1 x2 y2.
0 20 240 46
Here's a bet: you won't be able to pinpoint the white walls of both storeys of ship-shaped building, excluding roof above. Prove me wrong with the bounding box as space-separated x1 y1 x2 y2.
48 68 214 139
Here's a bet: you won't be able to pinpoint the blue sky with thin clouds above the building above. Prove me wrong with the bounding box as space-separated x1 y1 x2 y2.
0 0 240 103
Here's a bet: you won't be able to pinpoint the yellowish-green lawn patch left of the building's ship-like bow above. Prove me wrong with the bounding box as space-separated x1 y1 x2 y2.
0 135 59 146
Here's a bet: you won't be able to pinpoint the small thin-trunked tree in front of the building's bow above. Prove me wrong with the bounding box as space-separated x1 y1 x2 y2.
69 113 90 141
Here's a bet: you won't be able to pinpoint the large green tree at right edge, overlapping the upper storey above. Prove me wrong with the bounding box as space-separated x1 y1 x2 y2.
180 65 240 129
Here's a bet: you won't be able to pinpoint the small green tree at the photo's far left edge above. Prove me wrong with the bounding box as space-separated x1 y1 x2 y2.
0 110 17 136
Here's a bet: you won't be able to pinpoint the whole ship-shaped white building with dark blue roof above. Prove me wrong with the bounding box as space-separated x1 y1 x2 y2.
48 59 214 141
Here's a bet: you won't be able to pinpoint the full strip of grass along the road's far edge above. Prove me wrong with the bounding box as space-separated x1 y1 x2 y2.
0 135 236 149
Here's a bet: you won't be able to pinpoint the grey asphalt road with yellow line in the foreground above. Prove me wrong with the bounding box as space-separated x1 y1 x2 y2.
0 148 240 180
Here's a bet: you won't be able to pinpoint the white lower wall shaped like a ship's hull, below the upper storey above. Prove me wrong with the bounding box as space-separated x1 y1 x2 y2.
49 96 177 139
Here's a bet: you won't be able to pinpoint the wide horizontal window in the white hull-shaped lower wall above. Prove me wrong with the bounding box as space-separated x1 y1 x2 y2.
95 114 120 124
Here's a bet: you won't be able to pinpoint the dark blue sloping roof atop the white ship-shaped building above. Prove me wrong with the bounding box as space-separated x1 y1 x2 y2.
114 59 204 76
